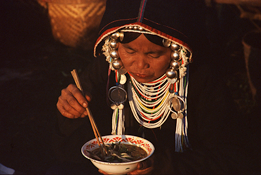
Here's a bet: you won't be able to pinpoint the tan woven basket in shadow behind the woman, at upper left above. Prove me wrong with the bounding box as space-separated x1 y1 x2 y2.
38 0 106 49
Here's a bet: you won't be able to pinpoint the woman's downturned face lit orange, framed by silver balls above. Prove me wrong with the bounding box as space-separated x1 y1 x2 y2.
118 34 171 83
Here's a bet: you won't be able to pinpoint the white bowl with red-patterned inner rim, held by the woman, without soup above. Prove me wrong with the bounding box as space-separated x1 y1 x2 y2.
81 135 155 174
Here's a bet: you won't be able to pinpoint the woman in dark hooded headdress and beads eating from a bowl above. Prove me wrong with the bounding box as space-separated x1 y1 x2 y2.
55 0 252 174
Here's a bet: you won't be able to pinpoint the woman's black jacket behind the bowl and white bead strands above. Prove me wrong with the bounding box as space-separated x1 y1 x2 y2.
54 56 252 174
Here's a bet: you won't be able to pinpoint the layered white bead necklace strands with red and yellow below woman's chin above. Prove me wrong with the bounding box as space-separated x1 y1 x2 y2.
128 75 171 128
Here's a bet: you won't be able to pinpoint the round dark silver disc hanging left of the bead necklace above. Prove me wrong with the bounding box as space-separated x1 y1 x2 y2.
108 86 127 106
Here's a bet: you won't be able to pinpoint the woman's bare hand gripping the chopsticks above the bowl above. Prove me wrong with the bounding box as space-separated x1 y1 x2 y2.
56 84 91 119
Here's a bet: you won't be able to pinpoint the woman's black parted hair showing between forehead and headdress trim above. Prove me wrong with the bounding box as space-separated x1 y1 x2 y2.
120 32 163 46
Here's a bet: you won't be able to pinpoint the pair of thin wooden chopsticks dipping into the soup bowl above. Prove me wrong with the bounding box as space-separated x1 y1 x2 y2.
71 69 108 154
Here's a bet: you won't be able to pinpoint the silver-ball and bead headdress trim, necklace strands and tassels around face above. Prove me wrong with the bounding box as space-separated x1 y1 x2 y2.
102 24 192 152
